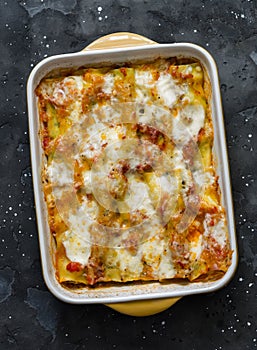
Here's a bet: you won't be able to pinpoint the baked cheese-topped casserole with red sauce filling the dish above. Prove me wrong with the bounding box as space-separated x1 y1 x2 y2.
36 57 232 287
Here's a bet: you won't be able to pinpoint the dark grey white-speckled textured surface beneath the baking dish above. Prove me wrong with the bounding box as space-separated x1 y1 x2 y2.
0 0 257 350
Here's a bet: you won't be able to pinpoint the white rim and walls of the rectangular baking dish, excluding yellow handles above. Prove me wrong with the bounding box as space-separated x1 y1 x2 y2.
27 37 237 303
